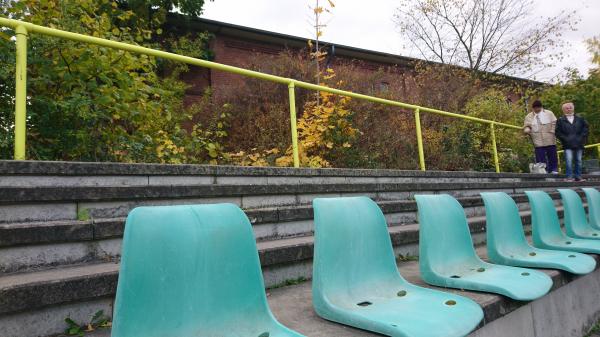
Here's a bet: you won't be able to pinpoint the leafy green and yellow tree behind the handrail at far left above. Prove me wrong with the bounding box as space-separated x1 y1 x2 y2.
0 0 223 162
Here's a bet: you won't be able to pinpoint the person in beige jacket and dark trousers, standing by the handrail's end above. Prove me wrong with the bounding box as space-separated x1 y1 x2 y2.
523 101 558 174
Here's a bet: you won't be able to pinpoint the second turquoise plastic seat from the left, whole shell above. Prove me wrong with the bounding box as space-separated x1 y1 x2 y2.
312 197 483 337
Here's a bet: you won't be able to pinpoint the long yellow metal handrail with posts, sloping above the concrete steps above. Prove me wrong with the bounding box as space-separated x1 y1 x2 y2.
0 17 521 172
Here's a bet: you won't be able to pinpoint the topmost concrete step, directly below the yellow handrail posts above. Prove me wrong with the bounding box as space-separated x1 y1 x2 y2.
0 160 576 187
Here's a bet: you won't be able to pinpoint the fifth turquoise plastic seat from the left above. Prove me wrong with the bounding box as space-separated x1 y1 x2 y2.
525 191 600 254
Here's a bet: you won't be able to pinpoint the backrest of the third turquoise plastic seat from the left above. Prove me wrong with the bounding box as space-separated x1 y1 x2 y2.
415 194 480 274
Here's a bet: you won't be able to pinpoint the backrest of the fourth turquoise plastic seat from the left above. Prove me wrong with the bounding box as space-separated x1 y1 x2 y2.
481 192 528 261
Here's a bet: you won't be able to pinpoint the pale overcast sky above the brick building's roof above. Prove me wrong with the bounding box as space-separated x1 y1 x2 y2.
202 0 600 81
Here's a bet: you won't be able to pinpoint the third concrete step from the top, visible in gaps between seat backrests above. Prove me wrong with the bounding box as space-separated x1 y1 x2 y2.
0 192 572 275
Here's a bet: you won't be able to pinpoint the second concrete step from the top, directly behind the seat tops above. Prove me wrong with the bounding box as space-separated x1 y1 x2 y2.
0 181 600 223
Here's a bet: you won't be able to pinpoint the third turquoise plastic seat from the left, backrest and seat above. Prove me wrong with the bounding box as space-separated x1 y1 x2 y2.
415 194 552 301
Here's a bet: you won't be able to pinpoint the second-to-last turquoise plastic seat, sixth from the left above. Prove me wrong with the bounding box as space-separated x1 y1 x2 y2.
558 188 600 240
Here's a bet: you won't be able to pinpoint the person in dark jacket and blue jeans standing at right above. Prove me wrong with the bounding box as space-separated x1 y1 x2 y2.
556 102 588 181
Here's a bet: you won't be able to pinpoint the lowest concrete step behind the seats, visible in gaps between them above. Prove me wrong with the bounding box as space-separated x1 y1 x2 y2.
0 206 562 315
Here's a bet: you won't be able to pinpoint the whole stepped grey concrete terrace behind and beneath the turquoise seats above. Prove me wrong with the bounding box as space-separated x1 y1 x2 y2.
0 161 600 337
